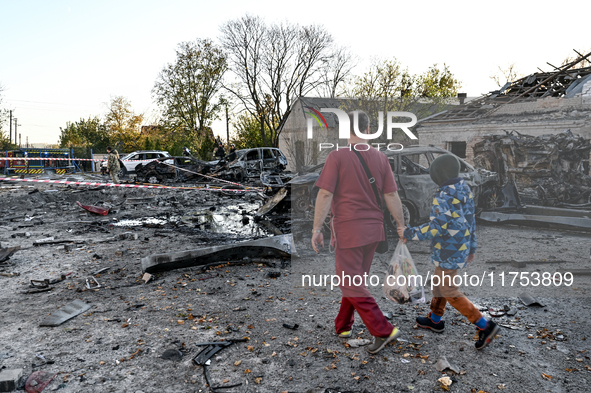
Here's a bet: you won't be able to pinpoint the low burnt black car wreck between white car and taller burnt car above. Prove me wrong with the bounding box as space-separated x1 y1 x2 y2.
135 156 215 183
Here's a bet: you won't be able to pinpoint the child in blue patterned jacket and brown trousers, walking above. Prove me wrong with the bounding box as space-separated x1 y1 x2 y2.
399 154 499 349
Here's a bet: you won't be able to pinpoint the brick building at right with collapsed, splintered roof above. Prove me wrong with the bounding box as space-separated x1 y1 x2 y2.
417 53 591 164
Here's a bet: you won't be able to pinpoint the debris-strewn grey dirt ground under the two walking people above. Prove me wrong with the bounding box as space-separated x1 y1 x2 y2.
0 178 591 393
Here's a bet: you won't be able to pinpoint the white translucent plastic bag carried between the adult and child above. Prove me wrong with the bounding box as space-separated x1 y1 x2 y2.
383 241 425 304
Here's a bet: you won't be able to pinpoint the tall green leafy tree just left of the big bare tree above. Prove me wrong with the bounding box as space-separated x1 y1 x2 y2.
152 39 228 157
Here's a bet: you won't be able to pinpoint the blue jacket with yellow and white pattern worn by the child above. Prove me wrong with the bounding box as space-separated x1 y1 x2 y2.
404 178 476 269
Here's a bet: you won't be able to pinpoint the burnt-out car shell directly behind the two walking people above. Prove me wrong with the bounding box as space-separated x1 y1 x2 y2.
289 146 498 226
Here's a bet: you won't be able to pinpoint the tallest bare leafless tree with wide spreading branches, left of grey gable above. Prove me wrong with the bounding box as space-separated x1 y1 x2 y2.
220 15 346 145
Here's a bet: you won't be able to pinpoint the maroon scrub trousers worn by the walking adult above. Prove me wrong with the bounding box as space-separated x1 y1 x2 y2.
335 242 394 337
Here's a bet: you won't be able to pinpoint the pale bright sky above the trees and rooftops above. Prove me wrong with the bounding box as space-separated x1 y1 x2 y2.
0 0 591 143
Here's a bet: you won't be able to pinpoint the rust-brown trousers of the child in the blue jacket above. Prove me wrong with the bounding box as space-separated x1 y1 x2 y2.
431 266 482 323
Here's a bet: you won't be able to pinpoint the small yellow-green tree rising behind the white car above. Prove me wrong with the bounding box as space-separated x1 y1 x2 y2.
105 96 144 152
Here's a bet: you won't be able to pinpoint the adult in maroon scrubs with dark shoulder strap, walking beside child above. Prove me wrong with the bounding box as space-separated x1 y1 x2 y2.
312 111 404 353
